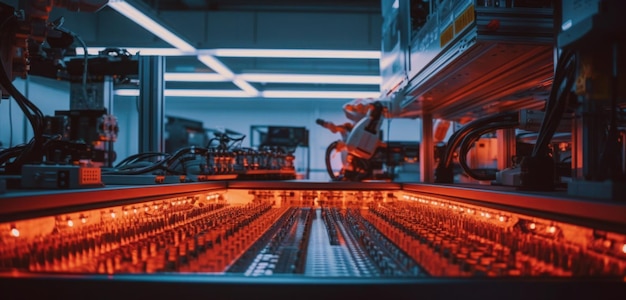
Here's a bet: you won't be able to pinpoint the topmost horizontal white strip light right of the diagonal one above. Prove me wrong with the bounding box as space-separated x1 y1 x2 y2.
210 49 380 59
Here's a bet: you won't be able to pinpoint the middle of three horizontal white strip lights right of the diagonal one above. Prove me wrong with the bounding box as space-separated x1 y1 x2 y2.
237 73 382 85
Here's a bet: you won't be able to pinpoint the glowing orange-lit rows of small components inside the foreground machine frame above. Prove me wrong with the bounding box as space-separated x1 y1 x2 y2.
0 184 626 279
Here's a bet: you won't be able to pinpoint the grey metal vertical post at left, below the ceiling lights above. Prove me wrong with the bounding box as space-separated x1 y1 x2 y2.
139 56 165 153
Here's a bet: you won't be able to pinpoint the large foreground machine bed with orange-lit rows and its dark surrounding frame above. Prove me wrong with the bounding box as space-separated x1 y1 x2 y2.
0 181 626 299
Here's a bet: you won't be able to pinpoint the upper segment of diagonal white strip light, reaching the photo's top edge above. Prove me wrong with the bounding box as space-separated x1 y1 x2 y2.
109 0 196 53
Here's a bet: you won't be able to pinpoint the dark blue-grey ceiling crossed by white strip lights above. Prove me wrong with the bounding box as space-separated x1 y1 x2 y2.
68 0 381 100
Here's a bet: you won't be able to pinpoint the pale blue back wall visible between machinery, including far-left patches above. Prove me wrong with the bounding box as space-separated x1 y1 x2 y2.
0 76 421 180
